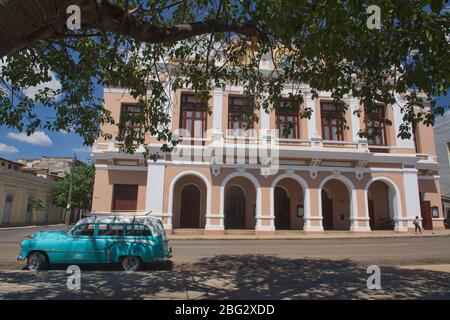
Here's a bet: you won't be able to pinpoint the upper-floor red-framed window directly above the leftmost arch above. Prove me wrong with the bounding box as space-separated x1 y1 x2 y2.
180 93 208 138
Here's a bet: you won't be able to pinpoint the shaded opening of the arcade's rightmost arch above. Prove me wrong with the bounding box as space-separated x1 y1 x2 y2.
367 181 395 230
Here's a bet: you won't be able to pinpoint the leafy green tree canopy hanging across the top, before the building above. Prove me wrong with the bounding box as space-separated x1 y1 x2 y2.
0 0 450 152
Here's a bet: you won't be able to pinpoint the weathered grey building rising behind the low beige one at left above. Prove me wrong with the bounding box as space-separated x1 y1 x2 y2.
18 156 85 178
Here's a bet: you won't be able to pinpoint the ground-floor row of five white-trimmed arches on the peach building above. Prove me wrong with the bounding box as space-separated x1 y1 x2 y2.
164 174 440 231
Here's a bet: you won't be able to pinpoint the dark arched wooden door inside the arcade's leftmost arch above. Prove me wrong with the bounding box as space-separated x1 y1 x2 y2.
180 184 200 228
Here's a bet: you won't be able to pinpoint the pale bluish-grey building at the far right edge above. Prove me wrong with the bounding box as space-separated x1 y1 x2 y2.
434 110 450 228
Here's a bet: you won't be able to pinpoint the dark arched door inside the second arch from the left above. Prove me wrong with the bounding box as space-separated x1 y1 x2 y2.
225 186 246 229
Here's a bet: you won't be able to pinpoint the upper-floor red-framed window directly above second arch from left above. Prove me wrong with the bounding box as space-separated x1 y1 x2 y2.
228 96 255 130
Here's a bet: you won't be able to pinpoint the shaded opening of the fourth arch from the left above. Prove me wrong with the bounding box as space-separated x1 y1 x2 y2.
321 179 351 230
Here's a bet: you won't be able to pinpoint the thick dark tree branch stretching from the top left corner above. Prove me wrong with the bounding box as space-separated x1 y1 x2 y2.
0 0 266 57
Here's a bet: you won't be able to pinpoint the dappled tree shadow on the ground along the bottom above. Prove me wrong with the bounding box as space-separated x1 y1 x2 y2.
0 255 450 299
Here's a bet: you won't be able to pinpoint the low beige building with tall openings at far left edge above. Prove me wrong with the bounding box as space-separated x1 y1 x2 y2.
0 158 65 226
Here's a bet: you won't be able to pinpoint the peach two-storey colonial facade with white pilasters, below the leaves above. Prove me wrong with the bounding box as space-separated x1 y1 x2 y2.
92 82 443 234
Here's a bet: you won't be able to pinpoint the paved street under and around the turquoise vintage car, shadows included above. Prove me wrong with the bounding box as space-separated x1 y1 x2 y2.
0 229 450 299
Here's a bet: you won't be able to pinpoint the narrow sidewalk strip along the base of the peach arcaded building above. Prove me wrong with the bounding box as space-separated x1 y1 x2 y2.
168 230 450 240
